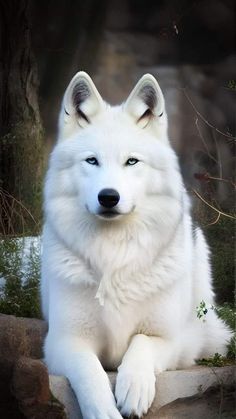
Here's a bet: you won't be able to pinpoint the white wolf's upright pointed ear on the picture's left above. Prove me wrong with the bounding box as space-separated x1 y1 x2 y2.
62 71 104 128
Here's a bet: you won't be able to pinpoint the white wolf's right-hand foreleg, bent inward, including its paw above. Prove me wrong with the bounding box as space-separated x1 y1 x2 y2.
115 334 182 417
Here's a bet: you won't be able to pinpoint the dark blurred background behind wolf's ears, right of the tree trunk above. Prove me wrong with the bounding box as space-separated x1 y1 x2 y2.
31 0 236 208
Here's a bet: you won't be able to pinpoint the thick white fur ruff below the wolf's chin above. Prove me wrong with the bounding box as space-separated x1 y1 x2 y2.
46 192 186 308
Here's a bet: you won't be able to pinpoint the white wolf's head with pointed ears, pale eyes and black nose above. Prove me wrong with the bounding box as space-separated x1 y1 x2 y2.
46 72 181 240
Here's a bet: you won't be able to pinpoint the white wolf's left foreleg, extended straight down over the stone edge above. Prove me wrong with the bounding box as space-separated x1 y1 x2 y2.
45 336 121 419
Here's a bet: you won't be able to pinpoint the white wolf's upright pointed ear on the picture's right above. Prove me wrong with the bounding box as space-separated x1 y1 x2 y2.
124 74 165 128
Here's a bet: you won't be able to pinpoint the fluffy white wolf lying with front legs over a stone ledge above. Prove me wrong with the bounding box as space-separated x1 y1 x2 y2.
42 72 230 419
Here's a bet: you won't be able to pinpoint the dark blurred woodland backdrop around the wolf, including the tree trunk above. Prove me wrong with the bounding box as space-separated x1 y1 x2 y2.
0 0 236 312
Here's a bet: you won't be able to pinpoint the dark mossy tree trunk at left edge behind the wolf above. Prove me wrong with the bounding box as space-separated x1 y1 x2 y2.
0 0 43 234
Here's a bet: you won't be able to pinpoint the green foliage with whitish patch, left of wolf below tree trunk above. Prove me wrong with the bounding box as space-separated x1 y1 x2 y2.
0 237 41 318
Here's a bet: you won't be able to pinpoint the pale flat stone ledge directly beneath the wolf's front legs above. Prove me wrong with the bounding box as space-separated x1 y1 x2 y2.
49 366 235 419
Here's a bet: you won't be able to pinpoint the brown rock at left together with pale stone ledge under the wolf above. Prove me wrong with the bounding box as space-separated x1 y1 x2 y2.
0 315 235 419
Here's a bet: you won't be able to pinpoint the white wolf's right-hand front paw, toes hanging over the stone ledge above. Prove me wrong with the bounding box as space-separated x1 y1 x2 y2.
115 365 156 417
